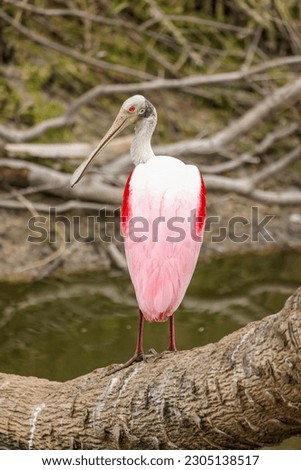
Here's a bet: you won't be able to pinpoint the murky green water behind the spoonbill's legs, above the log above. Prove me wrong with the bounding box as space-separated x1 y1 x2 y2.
0 251 301 449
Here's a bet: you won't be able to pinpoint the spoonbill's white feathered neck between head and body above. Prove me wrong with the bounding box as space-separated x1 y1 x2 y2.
131 115 157 166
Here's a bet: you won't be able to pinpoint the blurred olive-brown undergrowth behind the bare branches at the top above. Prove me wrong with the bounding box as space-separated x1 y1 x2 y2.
0 0 301 142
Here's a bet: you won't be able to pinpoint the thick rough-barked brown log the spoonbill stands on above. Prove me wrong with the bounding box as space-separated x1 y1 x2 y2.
0 288 301 449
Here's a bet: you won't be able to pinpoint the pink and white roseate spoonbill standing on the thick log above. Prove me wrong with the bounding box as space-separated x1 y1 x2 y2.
71 95 206 359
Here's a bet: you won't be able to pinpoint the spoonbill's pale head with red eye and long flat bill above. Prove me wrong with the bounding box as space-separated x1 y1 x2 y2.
71 95 156 187
